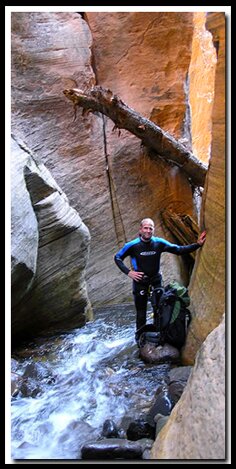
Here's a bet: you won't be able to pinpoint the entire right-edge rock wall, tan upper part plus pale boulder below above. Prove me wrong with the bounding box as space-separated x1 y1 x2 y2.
152 13 226 461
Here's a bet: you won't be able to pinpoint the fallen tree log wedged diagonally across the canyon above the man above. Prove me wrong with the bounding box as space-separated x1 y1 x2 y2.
63 86 207 186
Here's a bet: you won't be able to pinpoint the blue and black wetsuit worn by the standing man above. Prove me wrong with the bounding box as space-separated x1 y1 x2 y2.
114 236 201 330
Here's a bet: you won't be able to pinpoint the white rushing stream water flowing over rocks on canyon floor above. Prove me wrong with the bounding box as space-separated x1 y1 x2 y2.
11 305 169 460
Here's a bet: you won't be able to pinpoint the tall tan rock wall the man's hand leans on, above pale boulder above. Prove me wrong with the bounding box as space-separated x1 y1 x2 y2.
183 13 226 363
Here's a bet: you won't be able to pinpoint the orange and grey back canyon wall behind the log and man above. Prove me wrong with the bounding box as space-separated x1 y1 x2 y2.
12 12 225 344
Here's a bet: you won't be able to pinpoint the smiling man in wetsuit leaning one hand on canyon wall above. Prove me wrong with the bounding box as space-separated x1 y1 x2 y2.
114 218 206 340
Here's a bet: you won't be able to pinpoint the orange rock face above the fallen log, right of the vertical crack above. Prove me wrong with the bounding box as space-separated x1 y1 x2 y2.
87 12 194 138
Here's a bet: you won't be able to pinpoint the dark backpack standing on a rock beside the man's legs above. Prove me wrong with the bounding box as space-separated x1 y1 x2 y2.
158 282 191 349
